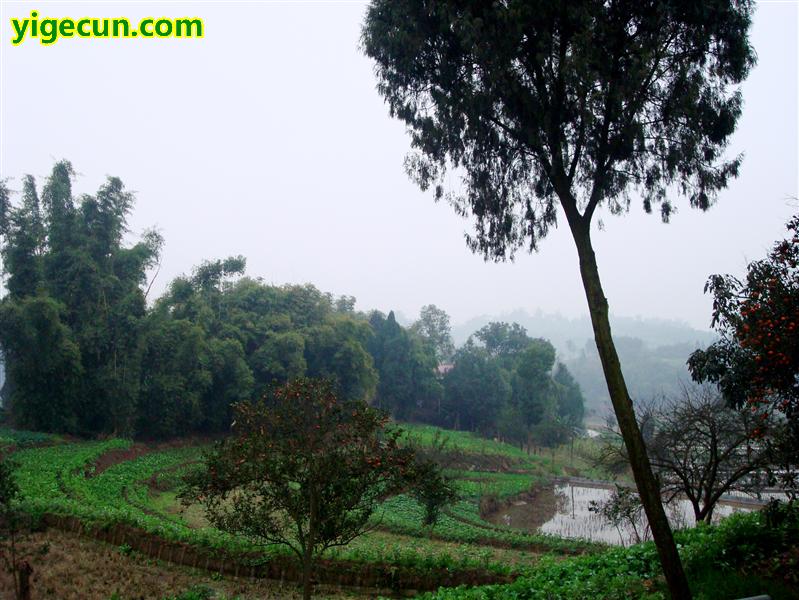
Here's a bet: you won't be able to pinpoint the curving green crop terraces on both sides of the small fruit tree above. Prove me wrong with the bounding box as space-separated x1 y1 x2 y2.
9 427 590 574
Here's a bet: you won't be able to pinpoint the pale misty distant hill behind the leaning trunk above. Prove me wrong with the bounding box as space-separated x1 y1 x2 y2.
452 310 716 414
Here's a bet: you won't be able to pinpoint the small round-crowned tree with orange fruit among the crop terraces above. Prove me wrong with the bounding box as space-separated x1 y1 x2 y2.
182 379 454 598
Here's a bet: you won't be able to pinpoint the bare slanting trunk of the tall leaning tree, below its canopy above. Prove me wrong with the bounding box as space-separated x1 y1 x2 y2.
569 220 691 600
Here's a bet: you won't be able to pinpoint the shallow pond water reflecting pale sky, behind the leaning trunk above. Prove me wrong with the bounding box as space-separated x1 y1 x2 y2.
489 482 758 545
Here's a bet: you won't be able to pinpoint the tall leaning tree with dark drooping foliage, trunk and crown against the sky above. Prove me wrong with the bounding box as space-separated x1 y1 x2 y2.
363 0 754 598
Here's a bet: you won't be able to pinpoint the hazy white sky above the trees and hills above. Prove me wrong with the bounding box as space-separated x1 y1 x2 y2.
0 0 799 334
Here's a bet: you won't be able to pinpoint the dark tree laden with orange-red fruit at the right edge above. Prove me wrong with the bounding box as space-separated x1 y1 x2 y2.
688 214 799 488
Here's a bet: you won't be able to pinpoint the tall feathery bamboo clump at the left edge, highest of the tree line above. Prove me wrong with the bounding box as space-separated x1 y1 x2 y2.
0 161 163 434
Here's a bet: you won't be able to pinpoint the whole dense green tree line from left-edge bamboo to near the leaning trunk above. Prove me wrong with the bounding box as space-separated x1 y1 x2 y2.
0 161 582 440
